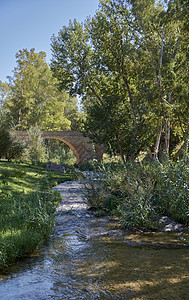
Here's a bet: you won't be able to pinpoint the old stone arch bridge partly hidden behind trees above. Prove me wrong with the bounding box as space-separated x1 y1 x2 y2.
14 131 104 164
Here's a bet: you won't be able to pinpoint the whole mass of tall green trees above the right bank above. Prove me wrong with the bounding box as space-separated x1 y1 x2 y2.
51 0 188 161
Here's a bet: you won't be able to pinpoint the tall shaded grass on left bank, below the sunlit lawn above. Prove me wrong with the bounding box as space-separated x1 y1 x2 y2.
0 191 61 267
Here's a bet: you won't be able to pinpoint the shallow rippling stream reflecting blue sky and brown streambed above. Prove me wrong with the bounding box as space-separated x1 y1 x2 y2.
0 182 189 300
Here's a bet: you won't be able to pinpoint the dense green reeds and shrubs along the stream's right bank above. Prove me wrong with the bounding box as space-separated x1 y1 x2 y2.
81 161 189 229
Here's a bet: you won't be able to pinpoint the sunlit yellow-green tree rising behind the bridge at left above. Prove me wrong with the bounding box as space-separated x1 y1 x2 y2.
6 49 71 130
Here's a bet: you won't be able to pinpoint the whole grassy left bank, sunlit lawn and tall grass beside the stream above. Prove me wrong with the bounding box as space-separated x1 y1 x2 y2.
0 161 77 268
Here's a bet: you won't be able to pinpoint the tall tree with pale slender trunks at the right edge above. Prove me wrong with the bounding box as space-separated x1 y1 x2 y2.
129 1 189 160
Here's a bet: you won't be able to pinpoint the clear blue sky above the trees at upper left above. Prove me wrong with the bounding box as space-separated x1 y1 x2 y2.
0 0 99 82
